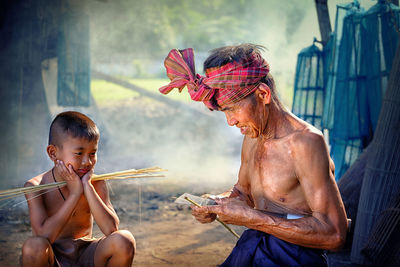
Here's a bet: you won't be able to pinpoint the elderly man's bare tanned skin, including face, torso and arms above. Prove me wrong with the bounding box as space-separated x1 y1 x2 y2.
192 84 347 250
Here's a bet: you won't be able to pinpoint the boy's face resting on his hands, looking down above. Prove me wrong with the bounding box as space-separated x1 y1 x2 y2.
52 135 98 178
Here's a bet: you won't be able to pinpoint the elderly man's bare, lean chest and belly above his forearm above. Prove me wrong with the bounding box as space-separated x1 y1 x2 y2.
236 118 333 215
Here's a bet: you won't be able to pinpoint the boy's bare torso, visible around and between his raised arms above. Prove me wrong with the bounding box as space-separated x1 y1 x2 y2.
30 171 93 239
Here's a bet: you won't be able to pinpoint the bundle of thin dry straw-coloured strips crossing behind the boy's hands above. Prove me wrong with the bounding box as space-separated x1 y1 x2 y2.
0 167 166 201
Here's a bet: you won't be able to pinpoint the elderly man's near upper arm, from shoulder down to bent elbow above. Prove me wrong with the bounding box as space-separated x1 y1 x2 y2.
293 133 348 250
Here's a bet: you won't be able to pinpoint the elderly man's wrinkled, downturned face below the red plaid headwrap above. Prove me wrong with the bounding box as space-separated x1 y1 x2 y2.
221 93 263 138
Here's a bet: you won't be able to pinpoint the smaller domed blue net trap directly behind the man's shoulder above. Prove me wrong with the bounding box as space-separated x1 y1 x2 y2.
292 44 324 129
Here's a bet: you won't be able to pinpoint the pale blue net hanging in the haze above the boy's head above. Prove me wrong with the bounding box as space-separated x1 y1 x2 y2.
57 10 90 106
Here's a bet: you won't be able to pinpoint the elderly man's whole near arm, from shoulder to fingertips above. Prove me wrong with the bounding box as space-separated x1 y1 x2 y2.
198 133 347 250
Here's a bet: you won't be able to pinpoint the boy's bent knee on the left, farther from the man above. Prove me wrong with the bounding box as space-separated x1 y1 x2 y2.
22 236 51 259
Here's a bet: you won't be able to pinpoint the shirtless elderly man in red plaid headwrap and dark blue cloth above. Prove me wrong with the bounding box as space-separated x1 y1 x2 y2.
160 44 347 266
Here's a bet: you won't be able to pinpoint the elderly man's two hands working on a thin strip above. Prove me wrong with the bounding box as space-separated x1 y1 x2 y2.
192 198 253 225
